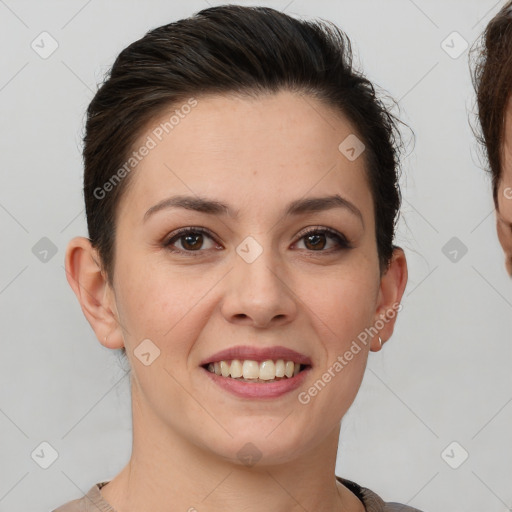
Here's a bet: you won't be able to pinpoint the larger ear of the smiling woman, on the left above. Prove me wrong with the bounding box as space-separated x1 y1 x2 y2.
65 237 124 349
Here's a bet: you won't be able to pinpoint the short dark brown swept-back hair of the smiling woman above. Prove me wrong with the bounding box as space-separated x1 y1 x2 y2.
83 5 402 283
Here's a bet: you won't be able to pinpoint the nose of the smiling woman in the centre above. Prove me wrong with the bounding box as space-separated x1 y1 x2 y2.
221 240 297 328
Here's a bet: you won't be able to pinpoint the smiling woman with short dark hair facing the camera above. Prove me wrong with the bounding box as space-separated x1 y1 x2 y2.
57 5 415 512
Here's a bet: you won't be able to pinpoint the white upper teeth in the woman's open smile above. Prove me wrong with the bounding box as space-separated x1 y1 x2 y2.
208 359 300 380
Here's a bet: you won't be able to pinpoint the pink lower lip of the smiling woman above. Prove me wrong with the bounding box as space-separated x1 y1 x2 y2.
201 367 311 398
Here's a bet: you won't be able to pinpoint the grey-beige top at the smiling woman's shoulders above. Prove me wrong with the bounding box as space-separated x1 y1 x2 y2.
52 476 421 512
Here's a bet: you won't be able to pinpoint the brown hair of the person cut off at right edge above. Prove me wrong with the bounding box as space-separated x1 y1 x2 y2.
470 0 512 205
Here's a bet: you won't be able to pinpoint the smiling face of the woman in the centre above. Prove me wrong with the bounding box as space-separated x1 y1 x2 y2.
93 92 400 463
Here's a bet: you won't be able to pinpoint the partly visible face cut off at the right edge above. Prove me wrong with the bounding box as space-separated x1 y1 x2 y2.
497 106 512 277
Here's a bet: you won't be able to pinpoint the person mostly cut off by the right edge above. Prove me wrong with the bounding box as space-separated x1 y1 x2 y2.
472 1 512 277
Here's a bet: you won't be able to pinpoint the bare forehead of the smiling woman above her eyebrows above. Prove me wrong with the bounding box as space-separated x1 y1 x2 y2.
122 91 371 220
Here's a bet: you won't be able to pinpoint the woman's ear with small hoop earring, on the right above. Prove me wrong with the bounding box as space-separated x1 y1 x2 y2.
370 247 407 352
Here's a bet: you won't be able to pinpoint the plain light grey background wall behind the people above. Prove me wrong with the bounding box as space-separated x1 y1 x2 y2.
0 0 512 512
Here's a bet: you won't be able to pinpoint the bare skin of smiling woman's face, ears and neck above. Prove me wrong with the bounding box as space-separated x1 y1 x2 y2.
66 92 407 512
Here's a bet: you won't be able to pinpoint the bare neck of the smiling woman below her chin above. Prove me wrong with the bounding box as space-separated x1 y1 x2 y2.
101 378 364 512
